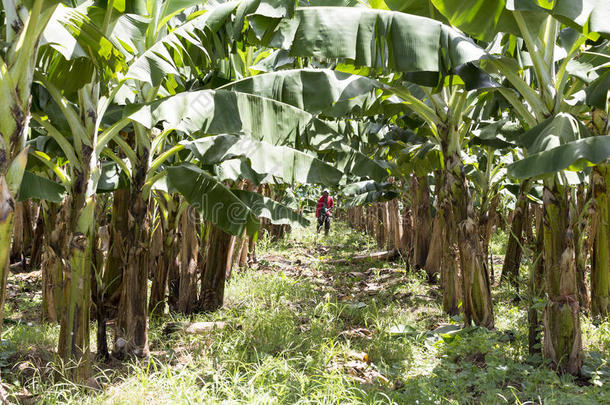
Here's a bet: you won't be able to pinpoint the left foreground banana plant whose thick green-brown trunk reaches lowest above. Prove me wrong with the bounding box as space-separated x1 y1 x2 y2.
33 3 129 381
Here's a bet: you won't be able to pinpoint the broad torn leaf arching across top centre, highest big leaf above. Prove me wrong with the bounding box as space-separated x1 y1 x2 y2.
258 7 486 73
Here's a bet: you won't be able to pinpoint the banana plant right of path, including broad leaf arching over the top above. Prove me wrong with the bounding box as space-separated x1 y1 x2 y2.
253 7 504 327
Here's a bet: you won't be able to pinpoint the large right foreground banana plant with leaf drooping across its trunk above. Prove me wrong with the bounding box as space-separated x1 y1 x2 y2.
433 0 610 374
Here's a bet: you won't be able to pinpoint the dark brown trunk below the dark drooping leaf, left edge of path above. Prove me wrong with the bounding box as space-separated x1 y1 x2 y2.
199 225 231 311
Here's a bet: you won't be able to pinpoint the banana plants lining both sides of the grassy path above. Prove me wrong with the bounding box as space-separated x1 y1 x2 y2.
0 0 610 380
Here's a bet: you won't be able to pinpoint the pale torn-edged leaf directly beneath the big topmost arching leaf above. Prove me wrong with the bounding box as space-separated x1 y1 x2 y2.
222 69 384 117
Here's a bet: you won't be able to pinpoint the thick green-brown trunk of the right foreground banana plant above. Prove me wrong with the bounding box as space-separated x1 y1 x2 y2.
543 181 583 375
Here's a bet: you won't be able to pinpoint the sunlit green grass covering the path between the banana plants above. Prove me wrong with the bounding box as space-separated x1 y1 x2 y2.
0 224 610 404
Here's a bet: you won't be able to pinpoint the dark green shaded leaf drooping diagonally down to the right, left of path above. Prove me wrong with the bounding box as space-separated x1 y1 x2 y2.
167 164 260 235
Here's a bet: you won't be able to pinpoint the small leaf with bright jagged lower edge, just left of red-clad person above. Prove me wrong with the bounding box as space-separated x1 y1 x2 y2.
233 190 309 227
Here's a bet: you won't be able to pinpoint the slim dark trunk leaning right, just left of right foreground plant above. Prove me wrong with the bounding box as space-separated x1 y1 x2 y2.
500 189 528 286
